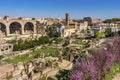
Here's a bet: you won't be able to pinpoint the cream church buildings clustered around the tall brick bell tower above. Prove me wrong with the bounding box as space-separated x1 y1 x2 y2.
57 13 88 37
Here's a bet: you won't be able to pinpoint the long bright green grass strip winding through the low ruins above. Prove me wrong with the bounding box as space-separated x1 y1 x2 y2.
4 47 57 63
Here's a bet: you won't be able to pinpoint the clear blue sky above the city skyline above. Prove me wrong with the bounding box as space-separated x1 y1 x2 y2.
0 0 120 19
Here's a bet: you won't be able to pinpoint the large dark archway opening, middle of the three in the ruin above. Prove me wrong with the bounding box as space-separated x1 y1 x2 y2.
10 22 22 34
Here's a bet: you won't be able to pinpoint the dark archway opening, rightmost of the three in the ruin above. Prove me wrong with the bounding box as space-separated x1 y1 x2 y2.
24 22 34 34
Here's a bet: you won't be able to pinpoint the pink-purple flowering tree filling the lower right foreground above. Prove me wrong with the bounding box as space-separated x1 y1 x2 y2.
70 37 120 80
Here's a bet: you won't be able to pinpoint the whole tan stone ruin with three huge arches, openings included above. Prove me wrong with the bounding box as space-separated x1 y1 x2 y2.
0 16 36 36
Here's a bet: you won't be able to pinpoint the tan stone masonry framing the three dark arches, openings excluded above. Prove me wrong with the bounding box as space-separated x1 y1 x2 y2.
0 17 36 36
